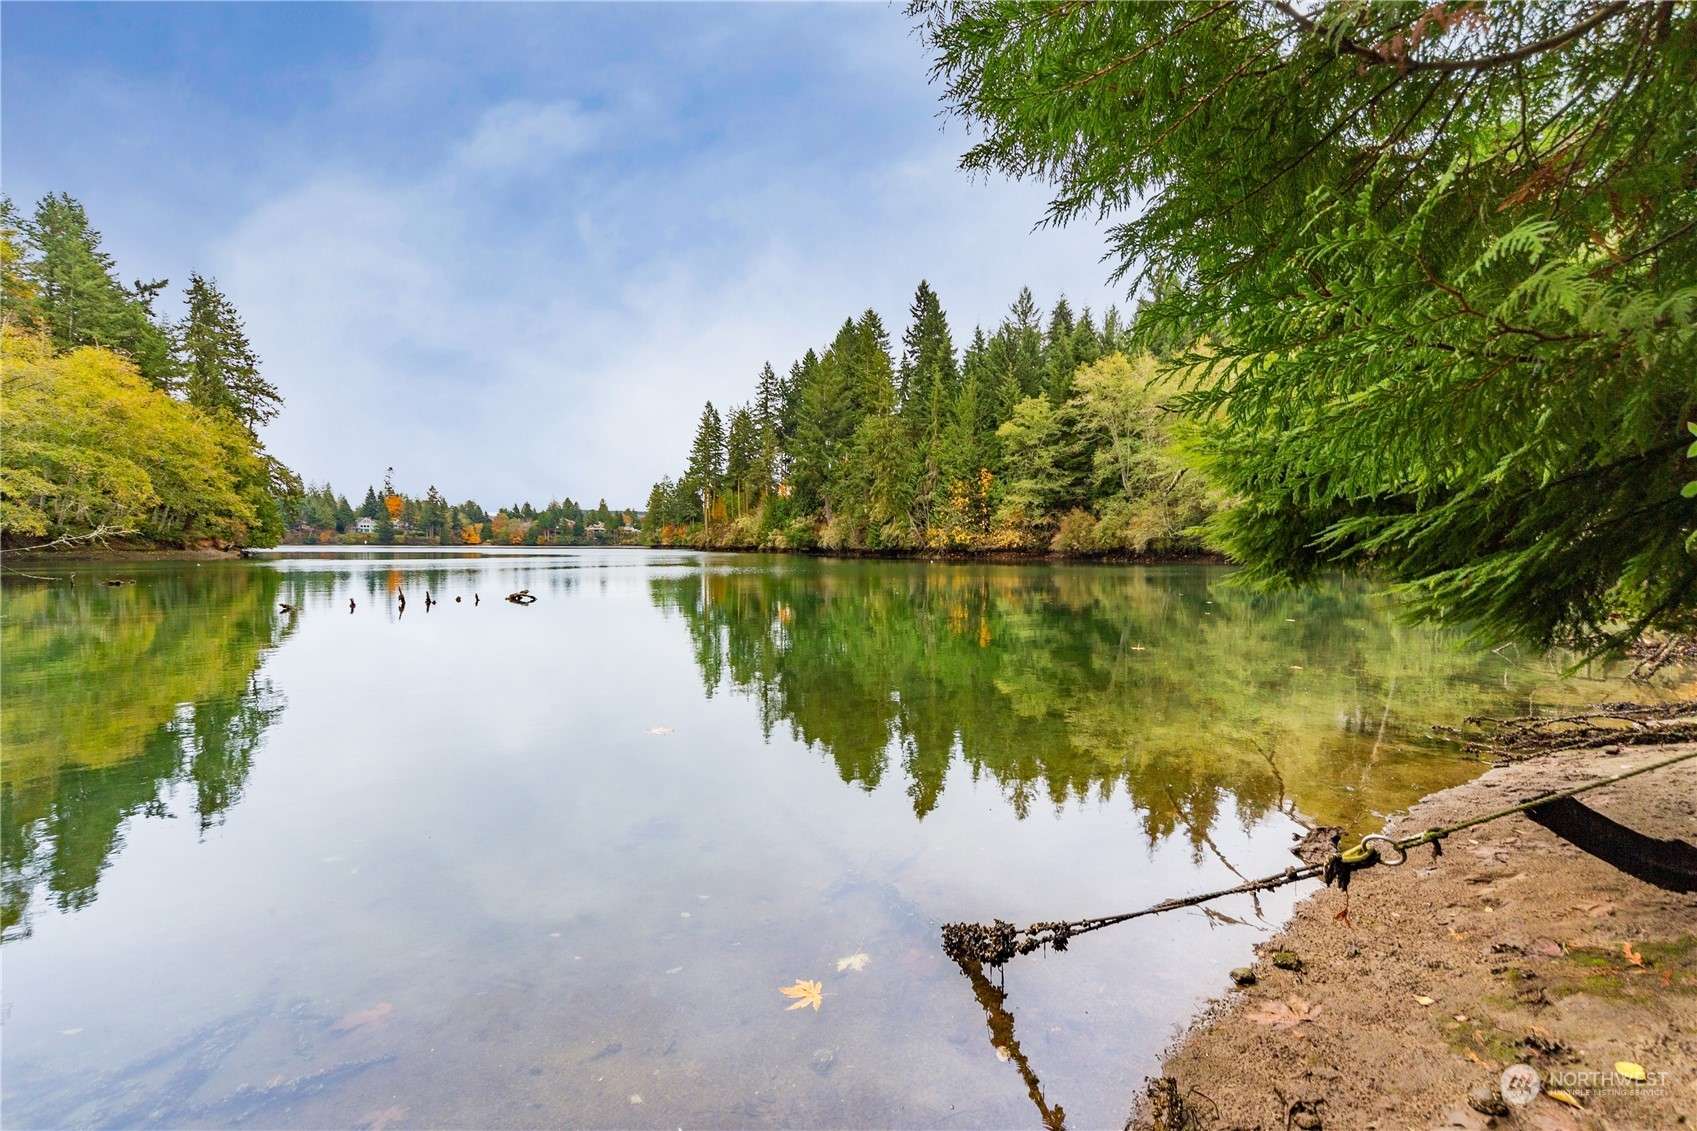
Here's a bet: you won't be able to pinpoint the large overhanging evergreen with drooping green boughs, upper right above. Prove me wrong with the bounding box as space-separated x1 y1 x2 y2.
911 0 1697 649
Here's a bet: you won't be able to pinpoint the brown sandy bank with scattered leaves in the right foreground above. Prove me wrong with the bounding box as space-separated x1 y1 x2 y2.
1127 744 1697 1131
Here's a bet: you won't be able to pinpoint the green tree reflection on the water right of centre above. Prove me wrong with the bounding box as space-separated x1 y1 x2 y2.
652 562 1599 835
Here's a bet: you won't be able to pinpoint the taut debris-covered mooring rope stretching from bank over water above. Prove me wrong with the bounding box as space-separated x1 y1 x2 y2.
944 751 1697 966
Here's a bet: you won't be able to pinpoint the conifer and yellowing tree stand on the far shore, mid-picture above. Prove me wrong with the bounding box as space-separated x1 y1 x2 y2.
645 282 1222 557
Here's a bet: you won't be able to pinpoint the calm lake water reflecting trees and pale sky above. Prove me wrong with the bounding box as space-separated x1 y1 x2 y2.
0 550 1683 1128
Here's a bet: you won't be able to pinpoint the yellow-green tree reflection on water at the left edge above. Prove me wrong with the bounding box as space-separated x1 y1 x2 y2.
0 566 288 939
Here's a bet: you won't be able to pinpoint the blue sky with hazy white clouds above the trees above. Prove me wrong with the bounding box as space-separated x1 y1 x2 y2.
13 3 1123 504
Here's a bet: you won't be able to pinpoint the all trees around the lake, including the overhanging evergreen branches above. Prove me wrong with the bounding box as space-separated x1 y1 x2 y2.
0 0 1697 654
